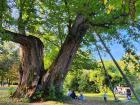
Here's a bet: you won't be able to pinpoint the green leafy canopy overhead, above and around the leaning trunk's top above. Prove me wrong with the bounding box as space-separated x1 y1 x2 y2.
0 0 140 46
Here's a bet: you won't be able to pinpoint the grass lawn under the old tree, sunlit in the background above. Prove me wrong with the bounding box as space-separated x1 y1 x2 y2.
0 87 139 105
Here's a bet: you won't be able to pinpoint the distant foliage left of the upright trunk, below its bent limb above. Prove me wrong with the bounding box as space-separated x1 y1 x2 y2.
0 42 19 85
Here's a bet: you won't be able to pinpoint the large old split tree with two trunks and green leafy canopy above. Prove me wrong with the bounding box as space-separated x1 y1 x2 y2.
0 0 140 98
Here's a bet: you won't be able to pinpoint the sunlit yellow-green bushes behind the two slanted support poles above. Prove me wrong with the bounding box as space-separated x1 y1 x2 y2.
64 58 137 93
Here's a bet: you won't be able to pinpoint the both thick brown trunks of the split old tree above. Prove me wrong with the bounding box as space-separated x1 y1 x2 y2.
0 14 88 98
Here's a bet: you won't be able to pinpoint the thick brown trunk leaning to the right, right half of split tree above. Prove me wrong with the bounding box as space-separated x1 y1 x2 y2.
42 15 88 96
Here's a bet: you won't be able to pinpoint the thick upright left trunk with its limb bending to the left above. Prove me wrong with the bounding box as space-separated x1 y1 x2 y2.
1 30 44 98
